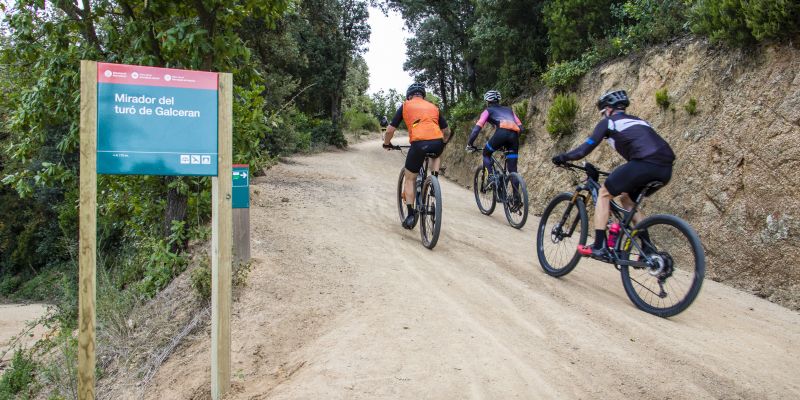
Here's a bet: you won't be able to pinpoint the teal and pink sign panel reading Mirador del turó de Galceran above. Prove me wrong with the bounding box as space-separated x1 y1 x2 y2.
97 63 218 176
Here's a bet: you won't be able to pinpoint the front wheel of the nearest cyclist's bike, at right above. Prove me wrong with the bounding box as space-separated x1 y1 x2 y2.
536 193 589 277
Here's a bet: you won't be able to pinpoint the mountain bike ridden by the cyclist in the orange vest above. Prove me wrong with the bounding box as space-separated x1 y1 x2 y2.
392 146 442 249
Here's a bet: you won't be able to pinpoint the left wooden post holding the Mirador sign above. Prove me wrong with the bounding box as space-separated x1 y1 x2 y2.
78 61 97 400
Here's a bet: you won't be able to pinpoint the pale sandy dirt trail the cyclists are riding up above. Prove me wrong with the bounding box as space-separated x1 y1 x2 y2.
145 141 800 399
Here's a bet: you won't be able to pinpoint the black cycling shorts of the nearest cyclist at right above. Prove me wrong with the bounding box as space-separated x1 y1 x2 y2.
604 160 672 201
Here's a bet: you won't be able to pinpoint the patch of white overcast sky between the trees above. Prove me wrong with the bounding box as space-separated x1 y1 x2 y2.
364 7 411 93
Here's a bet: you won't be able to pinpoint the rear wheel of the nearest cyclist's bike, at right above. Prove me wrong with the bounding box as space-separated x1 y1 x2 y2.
620 214 706 317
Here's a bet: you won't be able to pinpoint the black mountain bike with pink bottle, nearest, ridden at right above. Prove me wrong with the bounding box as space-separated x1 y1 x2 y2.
536 163 706 317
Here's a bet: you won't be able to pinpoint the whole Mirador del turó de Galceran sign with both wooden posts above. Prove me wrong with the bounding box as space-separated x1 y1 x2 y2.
78 61 233 400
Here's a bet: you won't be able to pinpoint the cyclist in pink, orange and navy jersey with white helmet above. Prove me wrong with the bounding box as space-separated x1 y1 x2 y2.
467 90 523 179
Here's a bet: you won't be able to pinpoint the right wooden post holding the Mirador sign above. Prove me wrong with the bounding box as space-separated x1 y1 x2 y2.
211 73 233 400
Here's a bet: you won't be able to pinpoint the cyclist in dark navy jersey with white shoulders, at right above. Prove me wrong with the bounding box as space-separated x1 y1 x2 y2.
553 90 675 261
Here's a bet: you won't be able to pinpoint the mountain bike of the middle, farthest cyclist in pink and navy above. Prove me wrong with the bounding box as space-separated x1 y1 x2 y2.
472 149 528 229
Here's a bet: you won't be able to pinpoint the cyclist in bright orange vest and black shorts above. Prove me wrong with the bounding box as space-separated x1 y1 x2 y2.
383 83 450 229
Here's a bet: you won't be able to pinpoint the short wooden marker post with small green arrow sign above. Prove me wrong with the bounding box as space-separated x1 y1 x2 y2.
232 164 250 264
